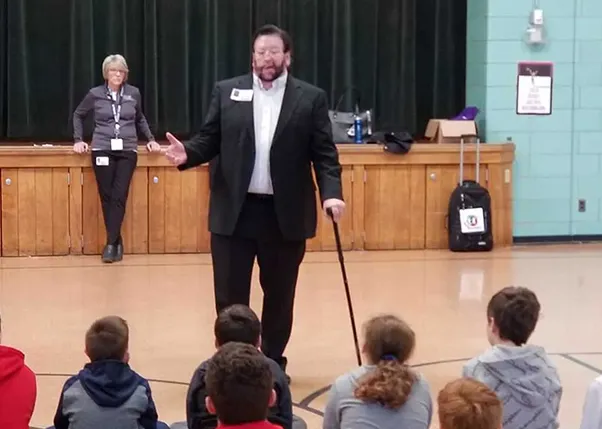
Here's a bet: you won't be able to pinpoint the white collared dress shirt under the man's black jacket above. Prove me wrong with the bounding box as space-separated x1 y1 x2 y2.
249 71 288 194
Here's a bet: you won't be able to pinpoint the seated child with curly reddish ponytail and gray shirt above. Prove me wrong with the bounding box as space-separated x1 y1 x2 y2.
323 315 433 429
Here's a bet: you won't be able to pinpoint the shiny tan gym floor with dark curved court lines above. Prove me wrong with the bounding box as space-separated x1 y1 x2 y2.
0 244 602 429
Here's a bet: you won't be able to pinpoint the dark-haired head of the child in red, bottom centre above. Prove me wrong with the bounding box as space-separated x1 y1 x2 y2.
205 342 273 425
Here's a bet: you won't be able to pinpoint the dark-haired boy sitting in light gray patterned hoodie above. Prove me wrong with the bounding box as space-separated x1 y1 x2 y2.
463 287 562 429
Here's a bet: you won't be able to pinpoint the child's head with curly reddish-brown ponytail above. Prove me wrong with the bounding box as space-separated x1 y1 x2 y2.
355 315 416 409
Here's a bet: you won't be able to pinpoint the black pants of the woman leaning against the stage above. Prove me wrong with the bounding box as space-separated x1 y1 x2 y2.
92 150 138 244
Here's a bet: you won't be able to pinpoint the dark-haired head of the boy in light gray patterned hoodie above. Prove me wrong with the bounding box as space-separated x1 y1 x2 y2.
487 286 541 346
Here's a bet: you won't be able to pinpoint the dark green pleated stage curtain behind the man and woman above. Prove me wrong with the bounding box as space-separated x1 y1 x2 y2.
0 0 466 142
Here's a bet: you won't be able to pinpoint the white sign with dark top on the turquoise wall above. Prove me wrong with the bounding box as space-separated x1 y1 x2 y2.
516 61 554 115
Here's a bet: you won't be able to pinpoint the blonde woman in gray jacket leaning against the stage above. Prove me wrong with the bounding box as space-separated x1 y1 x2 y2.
73 55 161 262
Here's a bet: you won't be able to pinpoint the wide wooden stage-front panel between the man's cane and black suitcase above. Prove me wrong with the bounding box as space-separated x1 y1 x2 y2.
364 165 425 250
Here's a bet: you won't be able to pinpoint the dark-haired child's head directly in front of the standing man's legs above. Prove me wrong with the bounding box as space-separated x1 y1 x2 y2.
213 304 261 346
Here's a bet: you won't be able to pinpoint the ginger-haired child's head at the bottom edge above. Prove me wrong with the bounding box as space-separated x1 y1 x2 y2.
437 378 502 429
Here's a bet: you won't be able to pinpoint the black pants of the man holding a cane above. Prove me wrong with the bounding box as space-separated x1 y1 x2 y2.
211 195 305 364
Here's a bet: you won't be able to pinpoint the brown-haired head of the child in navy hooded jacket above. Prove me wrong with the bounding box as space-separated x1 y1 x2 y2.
86 316 129 362
